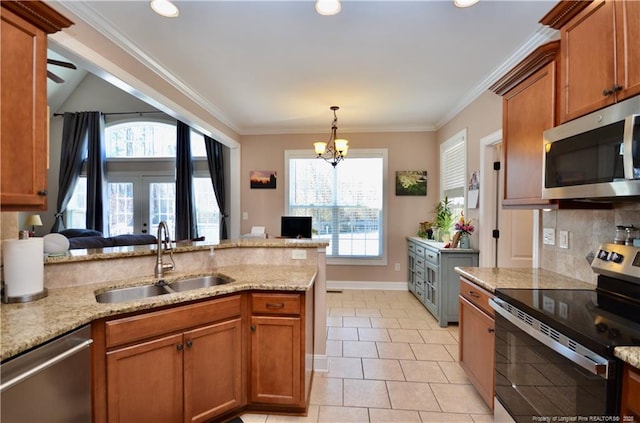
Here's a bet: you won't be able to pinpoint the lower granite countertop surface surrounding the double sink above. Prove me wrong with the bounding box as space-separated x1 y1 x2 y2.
0 265 317 361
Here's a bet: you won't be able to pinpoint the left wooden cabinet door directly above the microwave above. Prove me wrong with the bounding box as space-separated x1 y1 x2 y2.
560 0 616 122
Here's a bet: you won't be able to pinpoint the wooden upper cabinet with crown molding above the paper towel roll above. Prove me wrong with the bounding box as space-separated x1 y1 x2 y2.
0 1 72 211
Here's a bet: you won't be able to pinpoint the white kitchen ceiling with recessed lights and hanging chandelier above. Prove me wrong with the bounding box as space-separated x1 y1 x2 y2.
51 0 556 134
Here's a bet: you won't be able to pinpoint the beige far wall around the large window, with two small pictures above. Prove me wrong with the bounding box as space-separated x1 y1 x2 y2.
240 129 439 282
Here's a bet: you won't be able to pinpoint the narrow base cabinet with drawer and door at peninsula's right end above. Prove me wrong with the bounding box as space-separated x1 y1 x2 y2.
249 293 306 409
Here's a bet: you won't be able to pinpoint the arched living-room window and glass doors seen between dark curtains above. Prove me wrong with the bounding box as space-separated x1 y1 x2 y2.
65 121 220 242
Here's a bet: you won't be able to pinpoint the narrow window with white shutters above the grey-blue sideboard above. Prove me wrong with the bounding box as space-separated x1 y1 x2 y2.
440 129 467 217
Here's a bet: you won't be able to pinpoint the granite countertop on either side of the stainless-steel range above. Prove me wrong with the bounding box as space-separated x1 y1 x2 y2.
456 267 640 369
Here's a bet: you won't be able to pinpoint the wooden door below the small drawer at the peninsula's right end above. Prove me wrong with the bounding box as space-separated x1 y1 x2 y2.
250 316 304 405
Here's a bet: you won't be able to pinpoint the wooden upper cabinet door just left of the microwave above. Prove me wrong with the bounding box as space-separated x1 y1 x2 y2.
502 62 556 206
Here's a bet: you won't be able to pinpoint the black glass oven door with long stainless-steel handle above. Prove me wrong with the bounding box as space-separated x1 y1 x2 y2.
491 299 618 423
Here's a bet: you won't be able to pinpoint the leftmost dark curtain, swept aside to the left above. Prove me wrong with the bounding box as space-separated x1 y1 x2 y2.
51 113 90 232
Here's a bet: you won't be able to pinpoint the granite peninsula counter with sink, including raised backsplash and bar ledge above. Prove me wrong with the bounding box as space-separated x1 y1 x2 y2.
0 239 327 361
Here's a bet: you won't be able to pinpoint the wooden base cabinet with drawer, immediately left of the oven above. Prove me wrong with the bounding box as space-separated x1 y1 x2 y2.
458 278 495 409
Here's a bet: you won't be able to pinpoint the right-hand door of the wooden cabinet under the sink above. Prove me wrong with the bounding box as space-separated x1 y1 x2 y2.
184 318 242 422
